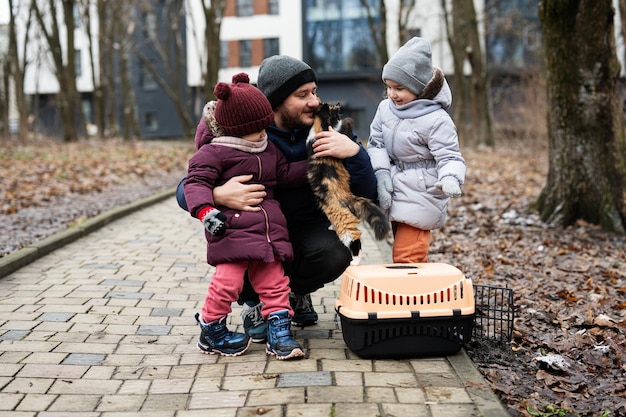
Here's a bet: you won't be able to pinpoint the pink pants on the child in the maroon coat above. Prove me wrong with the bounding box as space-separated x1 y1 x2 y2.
202 261 293 323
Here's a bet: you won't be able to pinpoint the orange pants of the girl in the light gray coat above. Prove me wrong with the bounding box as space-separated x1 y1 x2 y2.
392 222 430 264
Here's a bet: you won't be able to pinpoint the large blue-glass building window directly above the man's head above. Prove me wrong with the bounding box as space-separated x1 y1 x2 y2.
304 0 381 73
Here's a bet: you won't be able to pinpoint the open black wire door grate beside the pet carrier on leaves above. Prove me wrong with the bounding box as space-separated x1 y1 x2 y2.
472 284 514 343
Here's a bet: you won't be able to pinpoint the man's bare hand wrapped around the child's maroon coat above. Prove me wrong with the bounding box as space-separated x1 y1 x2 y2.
213 174 267 211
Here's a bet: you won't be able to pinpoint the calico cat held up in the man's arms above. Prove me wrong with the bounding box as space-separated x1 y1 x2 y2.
307 103 390 262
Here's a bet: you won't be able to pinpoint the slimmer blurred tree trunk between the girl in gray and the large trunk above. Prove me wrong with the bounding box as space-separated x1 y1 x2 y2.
441 0 494 146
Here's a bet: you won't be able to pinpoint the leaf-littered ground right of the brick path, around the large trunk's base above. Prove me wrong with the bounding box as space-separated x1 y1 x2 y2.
432 146 626 417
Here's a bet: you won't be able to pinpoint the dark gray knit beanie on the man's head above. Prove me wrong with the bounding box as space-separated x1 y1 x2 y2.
257 55 317 109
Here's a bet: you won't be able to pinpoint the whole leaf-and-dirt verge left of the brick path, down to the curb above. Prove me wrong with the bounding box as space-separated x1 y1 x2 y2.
0 139 194 257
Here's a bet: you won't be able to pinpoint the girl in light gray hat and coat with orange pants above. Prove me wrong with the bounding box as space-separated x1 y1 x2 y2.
367 37 465 263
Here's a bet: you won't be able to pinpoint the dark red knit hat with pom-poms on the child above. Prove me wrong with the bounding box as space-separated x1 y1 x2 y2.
213 72 274 137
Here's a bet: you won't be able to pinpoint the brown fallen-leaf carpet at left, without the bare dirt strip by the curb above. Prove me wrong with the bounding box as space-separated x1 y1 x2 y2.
0 140 193 214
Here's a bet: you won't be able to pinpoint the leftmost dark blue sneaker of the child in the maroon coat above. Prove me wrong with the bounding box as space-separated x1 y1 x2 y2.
196 313 252 356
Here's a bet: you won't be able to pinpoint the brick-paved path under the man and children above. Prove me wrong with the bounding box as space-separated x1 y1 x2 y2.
0 195 509 417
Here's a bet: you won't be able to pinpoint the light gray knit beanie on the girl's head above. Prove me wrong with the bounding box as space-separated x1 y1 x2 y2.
383 37 433 96
